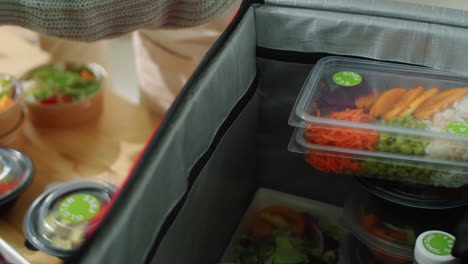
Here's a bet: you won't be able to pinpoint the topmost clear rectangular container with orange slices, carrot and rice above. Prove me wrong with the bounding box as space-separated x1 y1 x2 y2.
289 57 468 165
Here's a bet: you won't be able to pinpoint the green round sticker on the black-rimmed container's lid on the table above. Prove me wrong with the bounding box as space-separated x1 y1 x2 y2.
58 193 101 223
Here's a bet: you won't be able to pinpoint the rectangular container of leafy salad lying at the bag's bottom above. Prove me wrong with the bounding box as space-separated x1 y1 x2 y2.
221 189 345 264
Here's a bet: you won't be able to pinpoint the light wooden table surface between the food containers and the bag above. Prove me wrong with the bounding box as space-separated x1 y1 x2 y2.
0 90 159 264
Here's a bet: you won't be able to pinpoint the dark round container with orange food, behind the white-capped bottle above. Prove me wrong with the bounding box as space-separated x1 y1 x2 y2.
345 185 466 264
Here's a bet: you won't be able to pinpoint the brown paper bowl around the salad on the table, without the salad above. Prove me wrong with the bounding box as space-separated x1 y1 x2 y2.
21 62 107 127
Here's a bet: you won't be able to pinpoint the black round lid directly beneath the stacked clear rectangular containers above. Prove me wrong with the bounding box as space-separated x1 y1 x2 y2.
358 178 468 209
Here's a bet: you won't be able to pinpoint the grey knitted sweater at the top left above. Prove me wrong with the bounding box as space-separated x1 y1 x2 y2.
0 0 236 41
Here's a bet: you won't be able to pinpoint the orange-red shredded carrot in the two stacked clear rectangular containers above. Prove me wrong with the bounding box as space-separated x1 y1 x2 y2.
305 109 378 173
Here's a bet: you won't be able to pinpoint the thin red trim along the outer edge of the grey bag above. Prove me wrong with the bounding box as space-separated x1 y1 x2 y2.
87 117 164 236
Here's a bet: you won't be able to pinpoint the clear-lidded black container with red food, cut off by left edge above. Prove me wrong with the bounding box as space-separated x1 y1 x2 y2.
0 148 34 212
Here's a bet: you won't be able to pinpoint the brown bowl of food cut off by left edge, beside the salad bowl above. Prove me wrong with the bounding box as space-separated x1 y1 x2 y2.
0 74 23 137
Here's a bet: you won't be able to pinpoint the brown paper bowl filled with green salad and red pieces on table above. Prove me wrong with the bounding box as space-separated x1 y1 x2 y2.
21 62 106 127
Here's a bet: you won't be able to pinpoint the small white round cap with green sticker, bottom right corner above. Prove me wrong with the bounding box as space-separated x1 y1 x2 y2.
414 231 458 264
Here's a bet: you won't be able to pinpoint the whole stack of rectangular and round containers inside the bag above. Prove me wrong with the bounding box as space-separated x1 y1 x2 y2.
289 57 468 264
